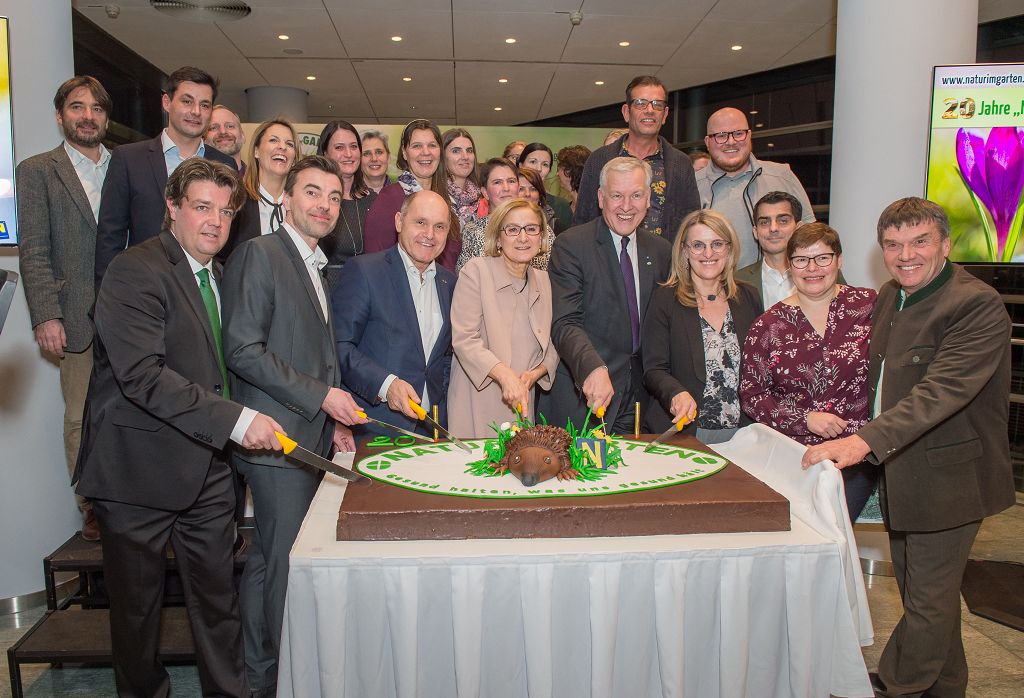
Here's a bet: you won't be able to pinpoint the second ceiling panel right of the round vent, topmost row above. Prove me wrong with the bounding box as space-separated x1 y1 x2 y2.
329 9 452 60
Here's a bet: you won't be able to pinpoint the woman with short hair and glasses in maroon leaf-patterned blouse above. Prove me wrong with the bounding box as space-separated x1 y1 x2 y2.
739 223 877 521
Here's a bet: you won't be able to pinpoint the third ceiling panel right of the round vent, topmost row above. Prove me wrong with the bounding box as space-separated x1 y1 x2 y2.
453 12 572 62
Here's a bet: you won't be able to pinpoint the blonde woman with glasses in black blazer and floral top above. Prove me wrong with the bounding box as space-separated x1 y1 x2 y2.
640 210 762 444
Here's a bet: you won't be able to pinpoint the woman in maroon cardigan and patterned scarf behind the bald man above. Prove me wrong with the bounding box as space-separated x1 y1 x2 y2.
364 119 462 271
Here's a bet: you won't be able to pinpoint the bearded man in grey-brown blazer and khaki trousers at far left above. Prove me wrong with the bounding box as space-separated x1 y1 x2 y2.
15 76 113 540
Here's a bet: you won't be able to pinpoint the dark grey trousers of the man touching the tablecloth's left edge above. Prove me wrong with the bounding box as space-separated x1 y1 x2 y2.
236 459 322 691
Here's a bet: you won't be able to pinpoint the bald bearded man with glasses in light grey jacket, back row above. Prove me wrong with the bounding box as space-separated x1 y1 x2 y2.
696 106 814 268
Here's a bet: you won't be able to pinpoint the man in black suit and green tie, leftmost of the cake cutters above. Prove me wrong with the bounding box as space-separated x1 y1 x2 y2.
76 159 282 697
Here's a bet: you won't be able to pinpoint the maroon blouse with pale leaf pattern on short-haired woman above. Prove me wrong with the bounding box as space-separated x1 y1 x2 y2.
739 286 877 445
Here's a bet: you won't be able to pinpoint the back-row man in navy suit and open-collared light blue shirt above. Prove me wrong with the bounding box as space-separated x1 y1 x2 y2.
95 67 236 288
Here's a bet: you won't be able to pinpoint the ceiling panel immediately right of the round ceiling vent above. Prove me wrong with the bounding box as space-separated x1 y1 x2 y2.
218 5 345 58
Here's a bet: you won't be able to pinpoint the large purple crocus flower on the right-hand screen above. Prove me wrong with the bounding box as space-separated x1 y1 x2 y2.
956 126 1024 258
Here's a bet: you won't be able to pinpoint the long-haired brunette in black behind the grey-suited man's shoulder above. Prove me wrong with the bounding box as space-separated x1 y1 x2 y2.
316 119 377 288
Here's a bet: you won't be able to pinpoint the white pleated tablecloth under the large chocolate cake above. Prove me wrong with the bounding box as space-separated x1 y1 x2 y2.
278 426 872 698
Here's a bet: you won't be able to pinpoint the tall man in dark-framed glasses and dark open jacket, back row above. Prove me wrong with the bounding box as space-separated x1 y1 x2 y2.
572 75 700 242
